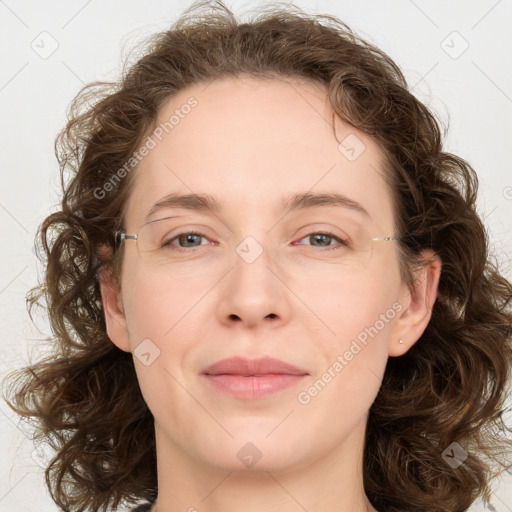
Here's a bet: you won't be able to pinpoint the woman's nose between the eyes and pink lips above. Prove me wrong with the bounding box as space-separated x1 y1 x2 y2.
218 236 291 328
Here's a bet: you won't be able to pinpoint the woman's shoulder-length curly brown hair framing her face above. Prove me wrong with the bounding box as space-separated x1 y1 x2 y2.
2 2 512 512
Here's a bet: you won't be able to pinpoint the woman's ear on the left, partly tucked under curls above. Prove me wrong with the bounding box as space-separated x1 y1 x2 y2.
99 248 131 352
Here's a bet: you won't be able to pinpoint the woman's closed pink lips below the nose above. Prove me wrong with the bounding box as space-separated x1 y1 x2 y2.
202 356 309 399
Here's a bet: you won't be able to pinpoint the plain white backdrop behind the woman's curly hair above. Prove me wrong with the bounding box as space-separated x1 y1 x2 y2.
0 0 512 512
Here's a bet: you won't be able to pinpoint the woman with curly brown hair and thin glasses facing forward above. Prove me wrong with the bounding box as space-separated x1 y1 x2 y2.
5 2 512 512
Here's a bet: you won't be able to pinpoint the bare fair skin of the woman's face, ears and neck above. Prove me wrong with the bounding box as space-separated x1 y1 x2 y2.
101 77 441 512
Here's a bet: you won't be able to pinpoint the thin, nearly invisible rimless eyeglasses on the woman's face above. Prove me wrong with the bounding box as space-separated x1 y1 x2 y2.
116 217 399 270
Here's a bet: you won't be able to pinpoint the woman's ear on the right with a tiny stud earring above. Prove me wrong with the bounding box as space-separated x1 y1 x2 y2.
388 249 442 357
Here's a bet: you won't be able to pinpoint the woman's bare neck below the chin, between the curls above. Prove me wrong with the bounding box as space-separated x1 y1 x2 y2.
151 416 377 512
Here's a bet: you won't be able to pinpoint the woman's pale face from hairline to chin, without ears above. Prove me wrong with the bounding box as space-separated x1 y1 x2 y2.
109 78 414 471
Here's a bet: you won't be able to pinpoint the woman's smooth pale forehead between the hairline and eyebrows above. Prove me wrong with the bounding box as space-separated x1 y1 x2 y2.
126 77 393 227
